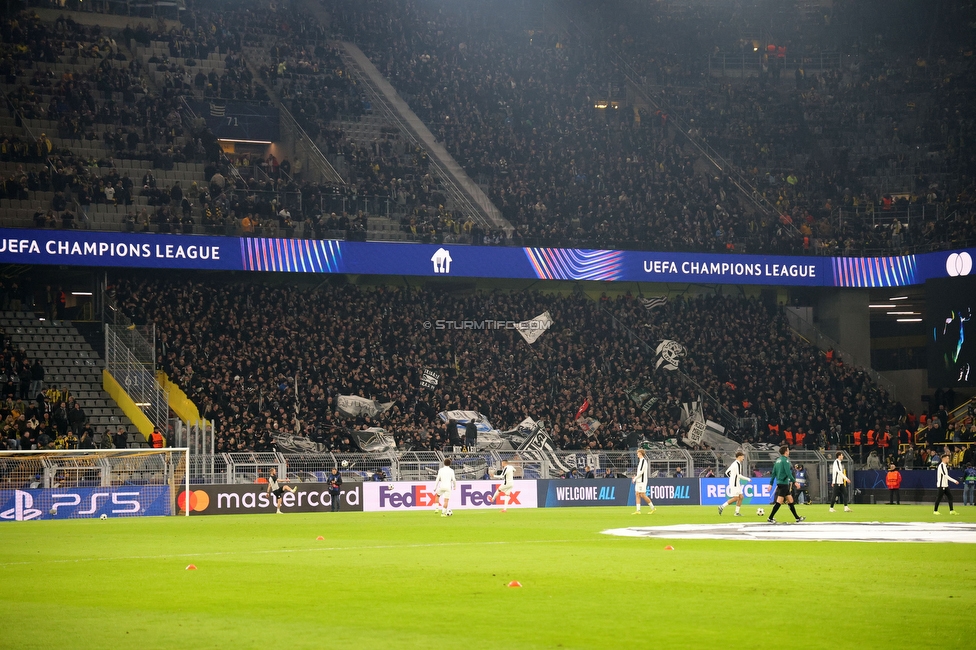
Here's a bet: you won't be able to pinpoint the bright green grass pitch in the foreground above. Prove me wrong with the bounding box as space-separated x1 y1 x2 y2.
0 505 976 650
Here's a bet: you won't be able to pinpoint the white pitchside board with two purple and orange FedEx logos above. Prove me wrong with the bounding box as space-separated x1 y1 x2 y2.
363 481 538 512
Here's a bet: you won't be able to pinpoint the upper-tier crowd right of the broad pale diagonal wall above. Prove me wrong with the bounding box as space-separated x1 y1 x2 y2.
330 0 974 253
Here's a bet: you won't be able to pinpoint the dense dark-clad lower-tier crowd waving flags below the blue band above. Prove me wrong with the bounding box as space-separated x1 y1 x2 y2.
116 278 903 451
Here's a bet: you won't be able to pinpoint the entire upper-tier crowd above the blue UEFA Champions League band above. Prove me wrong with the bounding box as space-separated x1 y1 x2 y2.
0 0 976 254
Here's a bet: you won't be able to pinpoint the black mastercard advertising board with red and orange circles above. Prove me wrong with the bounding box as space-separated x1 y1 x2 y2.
176 481 368 515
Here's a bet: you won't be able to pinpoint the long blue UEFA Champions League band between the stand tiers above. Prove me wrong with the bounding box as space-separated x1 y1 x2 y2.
0 228 976 287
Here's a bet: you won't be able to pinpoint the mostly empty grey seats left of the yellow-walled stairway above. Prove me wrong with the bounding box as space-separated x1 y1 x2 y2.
0 311 148 447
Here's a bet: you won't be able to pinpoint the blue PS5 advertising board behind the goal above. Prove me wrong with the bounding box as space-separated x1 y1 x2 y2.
0 485 173 521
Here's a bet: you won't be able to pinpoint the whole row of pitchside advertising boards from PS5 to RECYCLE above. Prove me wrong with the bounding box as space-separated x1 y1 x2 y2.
0 472 892 521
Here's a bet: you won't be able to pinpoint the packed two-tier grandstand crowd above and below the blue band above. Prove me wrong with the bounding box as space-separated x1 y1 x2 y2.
0 0 976 460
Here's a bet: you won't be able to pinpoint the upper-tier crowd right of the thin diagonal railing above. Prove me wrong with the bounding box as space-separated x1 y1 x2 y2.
581 2 976 252
